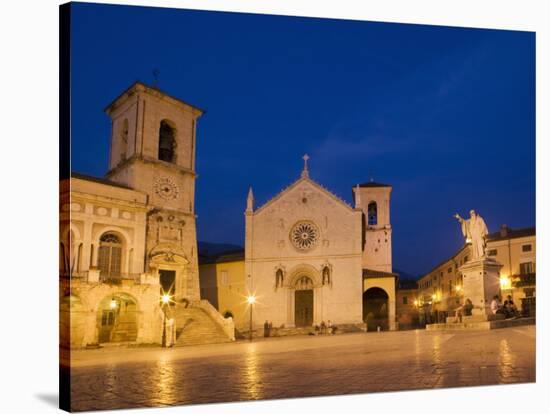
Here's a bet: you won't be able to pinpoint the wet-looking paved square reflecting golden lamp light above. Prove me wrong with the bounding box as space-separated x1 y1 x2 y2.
67 326 535 411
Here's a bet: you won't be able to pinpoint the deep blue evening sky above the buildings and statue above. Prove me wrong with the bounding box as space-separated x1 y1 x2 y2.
72 3 535 274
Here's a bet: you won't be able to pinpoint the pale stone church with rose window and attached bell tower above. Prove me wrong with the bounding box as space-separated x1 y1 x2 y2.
209 156 397 331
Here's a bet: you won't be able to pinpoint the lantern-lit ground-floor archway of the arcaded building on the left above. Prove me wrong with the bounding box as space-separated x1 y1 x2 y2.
97 293 138 343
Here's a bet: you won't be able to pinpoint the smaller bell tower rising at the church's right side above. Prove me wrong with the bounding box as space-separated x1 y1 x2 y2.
353 180 392 272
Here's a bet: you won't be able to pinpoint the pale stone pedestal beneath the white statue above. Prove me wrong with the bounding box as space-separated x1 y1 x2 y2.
459 258 502 320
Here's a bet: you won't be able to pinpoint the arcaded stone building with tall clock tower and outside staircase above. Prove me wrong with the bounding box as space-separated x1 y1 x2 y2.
60 82 234 347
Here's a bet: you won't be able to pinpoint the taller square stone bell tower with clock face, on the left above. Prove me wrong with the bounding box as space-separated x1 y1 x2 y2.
105 82 203 300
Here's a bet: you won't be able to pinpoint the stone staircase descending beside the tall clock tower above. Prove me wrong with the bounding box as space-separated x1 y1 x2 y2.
168 303 235 346
